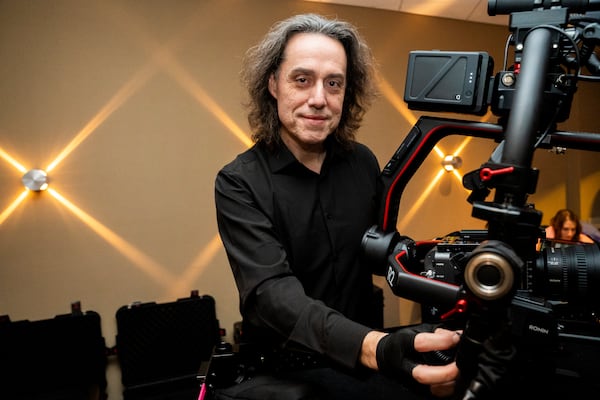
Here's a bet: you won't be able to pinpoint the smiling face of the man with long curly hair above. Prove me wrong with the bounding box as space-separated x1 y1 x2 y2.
269 33 346 147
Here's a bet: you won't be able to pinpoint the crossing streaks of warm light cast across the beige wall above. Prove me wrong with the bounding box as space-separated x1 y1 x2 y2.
0 4 492 298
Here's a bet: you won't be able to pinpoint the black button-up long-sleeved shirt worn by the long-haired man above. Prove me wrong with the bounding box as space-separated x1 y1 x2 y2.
215 141 380 367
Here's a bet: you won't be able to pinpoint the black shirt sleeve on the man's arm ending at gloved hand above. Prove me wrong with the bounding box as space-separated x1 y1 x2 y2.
215 159 370 368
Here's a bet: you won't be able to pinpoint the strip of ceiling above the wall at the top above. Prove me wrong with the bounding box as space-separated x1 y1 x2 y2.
308 0 508 26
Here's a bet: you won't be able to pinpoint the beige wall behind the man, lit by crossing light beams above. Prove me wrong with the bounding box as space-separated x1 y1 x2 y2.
0 0 600 399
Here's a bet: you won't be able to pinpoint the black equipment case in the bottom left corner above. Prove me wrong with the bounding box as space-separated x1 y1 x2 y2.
0 302 107 400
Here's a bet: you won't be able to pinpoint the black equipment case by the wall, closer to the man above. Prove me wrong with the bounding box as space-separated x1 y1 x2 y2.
116 291 221 400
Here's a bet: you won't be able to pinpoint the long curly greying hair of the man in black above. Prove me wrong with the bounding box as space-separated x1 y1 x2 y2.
241 14 377 147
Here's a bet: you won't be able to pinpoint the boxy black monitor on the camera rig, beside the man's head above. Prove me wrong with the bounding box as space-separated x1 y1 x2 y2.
404 51 494 115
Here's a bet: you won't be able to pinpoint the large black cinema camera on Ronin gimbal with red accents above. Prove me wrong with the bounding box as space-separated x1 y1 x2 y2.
362 0 600 399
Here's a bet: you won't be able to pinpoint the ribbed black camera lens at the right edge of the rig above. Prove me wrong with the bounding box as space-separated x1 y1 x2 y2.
533 244 600 305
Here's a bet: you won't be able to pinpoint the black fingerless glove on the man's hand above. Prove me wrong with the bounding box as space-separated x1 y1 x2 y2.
375 324 451 377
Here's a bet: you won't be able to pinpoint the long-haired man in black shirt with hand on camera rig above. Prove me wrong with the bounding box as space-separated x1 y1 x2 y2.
215 14 458 399
